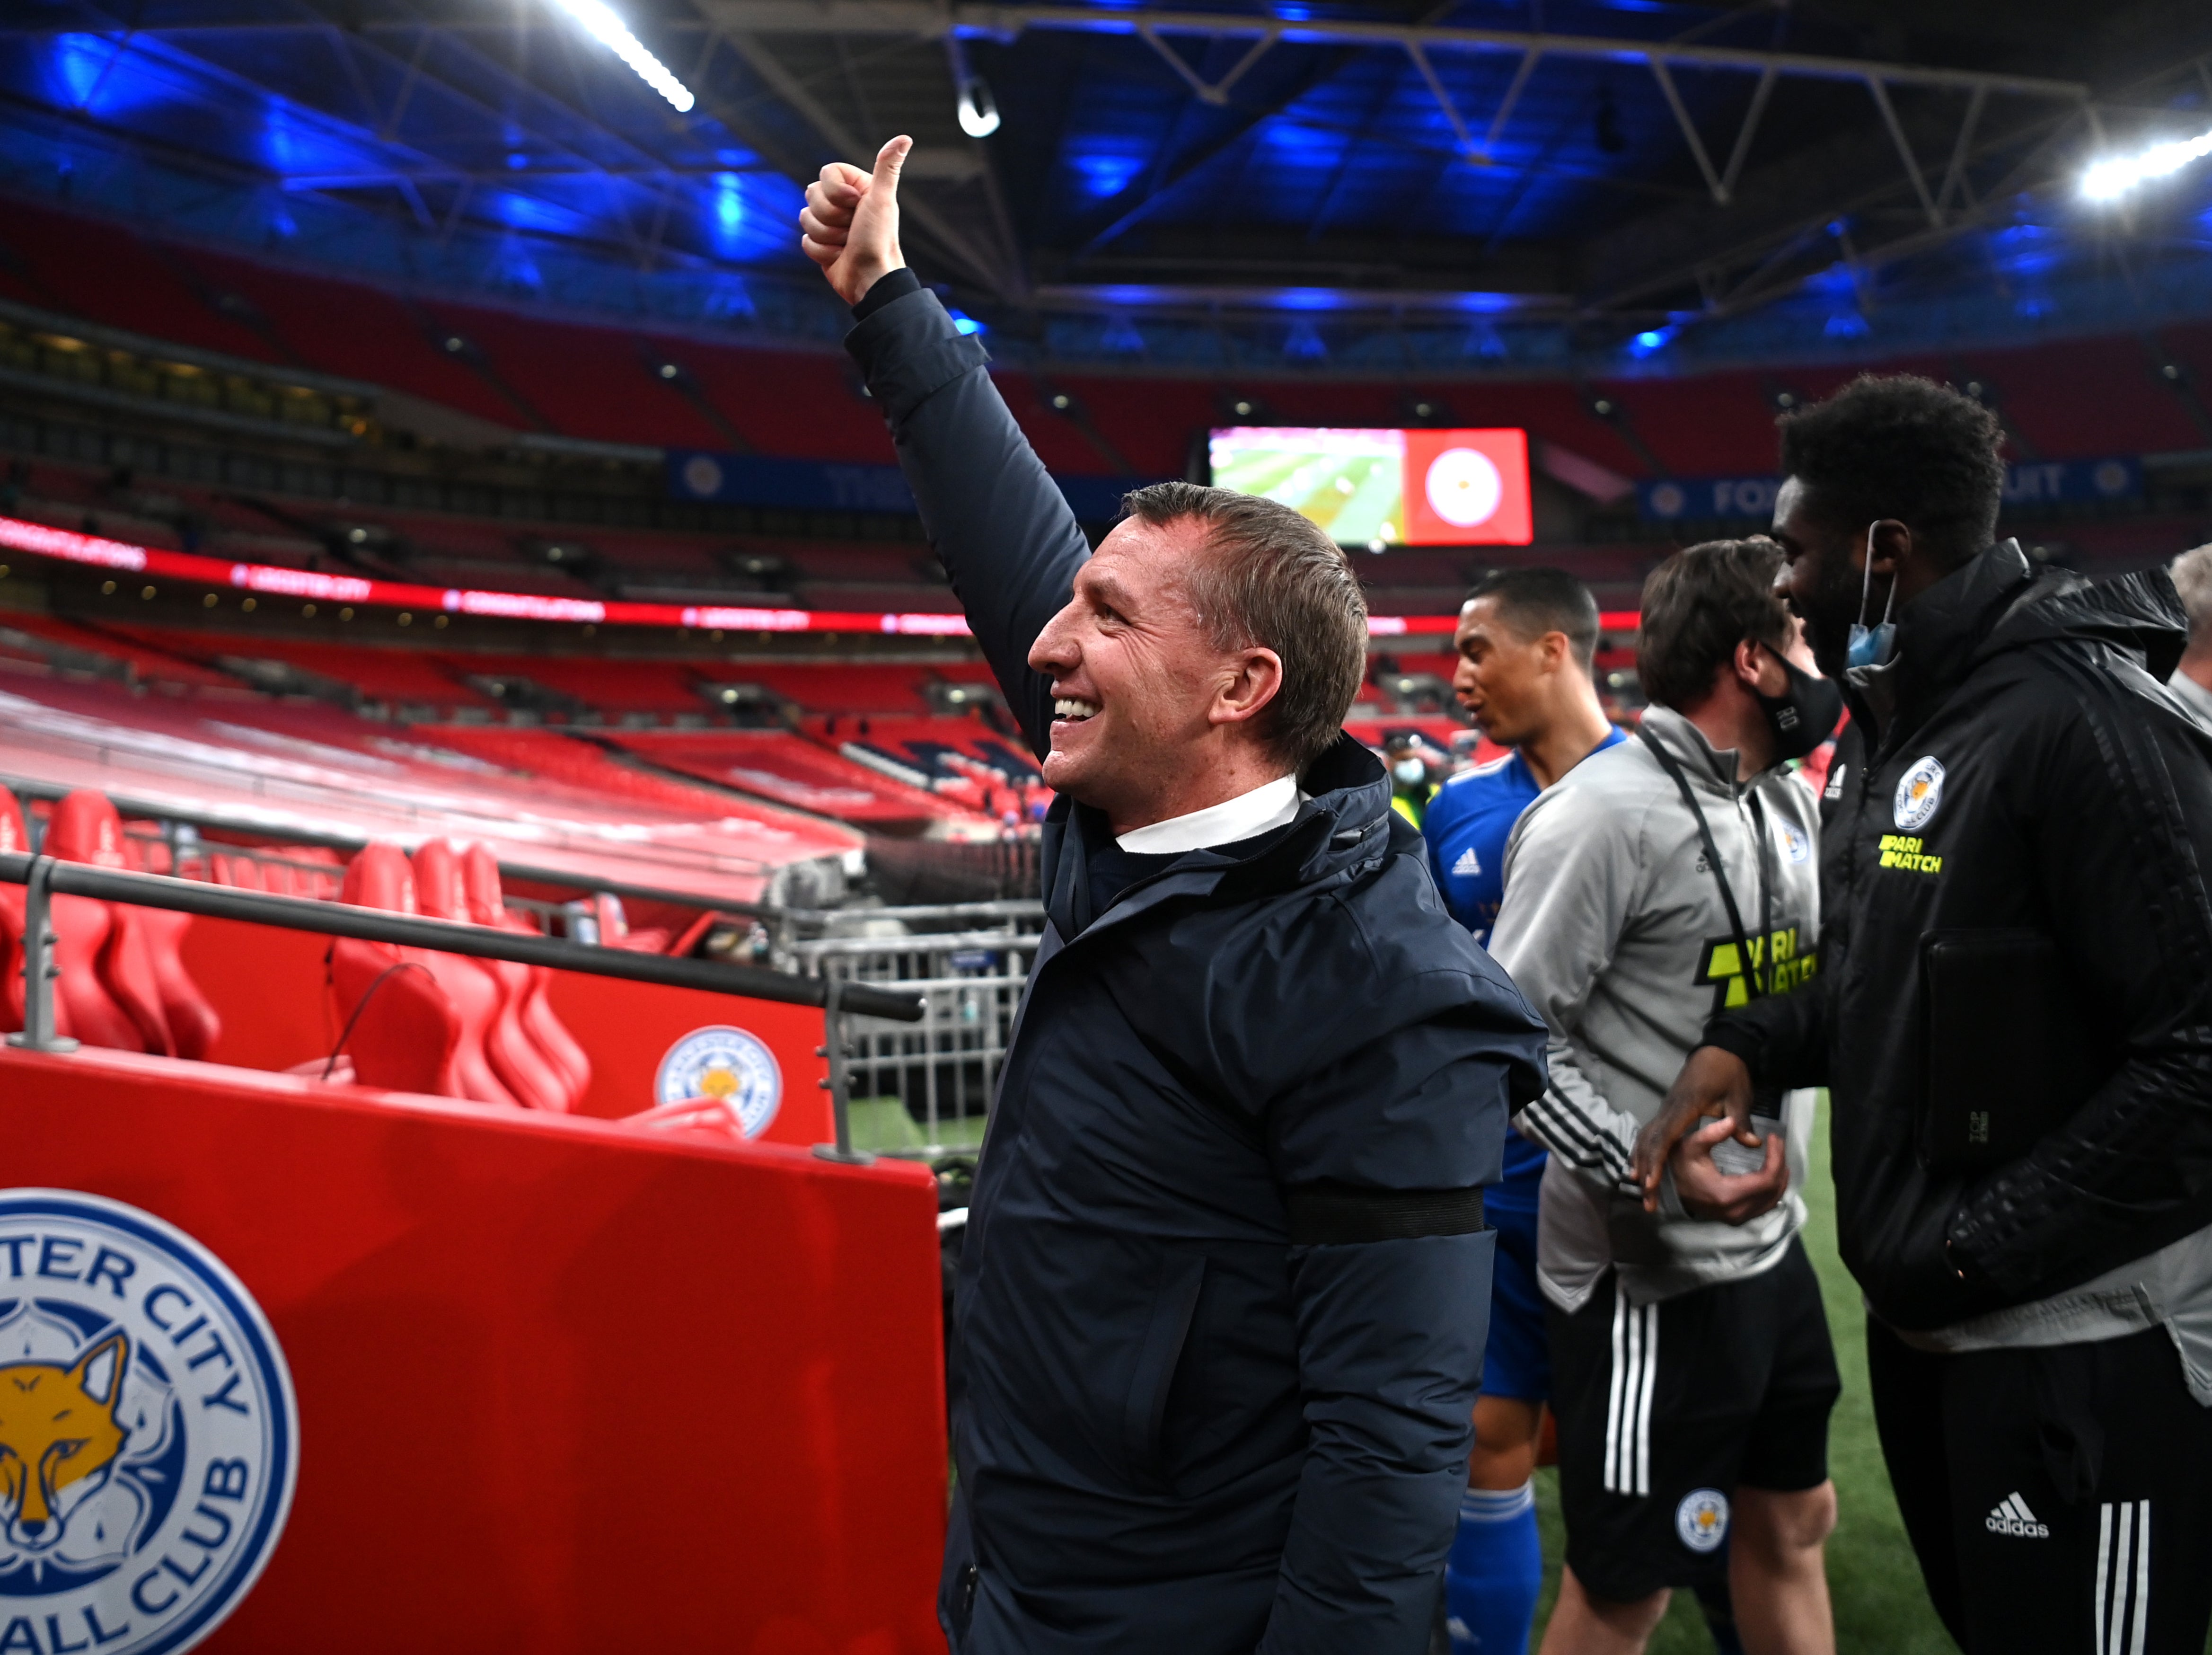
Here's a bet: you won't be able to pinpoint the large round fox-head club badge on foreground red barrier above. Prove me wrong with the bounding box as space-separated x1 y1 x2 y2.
0 1190 299 1655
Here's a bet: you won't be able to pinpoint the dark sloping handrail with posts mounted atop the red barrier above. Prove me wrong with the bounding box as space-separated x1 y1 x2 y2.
0 852 927 1161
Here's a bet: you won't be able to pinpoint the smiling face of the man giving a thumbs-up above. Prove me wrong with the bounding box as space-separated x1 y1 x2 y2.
1029 518 1241 821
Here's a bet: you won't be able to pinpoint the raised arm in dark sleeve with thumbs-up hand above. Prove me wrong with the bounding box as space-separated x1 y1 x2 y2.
799 137 1091 759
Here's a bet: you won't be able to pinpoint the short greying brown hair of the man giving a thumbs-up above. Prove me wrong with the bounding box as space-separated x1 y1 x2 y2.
1121 471 1367 770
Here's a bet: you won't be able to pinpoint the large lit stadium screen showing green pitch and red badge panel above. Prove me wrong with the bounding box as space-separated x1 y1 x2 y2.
1210 425 1535 551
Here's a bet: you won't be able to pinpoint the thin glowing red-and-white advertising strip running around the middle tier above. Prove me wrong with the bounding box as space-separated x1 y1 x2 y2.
0 518 1635 637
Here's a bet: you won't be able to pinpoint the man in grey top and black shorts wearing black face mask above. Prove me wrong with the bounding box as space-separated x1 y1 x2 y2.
1491 542 1841 1655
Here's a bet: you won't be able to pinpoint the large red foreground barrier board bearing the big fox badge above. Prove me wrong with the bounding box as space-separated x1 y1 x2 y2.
0 1049 944 1655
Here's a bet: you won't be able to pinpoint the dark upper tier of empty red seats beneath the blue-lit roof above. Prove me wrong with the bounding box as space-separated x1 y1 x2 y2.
17 188 2212 504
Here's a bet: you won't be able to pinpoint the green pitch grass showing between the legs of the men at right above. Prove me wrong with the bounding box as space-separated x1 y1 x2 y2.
1531 1097 1957 1655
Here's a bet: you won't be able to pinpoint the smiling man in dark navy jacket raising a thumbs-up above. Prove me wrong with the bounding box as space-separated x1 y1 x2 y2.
801 140 1544 1655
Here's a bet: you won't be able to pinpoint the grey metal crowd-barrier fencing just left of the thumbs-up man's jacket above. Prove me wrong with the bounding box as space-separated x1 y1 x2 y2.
790 903 1044 1157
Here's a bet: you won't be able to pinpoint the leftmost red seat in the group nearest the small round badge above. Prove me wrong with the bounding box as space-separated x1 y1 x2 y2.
330 843 465 1097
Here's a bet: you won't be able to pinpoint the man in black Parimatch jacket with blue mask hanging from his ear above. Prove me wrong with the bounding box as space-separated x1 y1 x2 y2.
1637 378 2212 1655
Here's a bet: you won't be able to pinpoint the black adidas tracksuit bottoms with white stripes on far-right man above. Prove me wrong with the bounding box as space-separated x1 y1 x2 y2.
1867 1317 2212 1655
